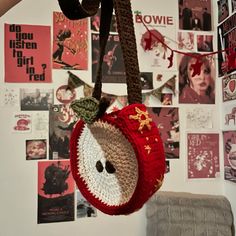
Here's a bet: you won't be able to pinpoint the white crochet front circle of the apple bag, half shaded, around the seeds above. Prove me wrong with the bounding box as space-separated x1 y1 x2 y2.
77 121 138 206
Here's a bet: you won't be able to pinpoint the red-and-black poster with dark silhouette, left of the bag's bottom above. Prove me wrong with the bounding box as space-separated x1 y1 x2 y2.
38 161 75 224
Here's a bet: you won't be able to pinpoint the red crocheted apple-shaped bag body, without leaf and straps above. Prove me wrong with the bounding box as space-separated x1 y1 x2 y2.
70 104 165 215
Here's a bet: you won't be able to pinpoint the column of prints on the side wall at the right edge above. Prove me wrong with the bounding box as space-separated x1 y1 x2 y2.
217 0 236 182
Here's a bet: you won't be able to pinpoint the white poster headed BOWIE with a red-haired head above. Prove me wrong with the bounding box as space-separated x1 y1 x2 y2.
133 0 177 73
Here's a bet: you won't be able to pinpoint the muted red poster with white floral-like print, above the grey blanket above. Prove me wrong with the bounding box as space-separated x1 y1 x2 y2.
188 133 220 179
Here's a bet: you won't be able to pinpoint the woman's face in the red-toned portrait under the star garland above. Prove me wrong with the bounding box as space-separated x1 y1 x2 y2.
188 59 211 95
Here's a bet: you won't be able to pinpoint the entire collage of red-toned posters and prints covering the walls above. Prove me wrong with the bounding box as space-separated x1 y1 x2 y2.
0 0 236 224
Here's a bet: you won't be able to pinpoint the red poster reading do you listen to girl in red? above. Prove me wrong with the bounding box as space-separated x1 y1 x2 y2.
4 24 51 83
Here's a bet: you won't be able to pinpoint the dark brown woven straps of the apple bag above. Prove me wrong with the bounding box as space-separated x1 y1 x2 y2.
58 0 142 104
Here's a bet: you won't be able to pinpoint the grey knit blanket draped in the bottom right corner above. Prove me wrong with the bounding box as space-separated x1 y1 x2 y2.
146 191 235 236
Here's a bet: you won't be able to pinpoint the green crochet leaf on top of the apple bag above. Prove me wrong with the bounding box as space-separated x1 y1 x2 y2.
70 97 99 124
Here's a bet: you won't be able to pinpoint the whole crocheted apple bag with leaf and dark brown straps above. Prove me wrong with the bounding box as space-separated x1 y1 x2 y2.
59 0 165 215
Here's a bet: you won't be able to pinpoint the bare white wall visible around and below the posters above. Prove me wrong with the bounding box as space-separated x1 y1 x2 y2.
0 0 236 236
